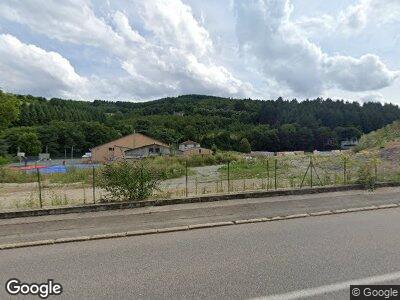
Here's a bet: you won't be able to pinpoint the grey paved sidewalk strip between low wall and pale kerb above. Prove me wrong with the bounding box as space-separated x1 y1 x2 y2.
0 188 400 244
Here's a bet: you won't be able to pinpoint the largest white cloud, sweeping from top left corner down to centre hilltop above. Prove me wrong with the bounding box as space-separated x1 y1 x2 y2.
0 0 252 99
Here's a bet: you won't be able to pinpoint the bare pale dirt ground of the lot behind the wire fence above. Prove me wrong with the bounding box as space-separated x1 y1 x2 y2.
0 166 272 210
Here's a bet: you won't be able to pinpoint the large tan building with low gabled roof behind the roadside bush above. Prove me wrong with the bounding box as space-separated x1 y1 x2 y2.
91 133 169 162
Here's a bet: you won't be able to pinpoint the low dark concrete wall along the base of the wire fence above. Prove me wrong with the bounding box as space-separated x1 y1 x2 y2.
0 182 400 219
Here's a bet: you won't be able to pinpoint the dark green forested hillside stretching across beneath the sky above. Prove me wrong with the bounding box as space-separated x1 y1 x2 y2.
0 93 400 156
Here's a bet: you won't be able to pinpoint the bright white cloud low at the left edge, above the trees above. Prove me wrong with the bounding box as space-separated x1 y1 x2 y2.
0 34 87 98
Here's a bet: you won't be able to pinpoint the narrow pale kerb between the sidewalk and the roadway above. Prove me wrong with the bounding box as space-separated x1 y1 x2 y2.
0 203 400 250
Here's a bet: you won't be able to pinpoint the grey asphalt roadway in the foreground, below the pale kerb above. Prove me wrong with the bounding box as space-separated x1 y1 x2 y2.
0 208 400 299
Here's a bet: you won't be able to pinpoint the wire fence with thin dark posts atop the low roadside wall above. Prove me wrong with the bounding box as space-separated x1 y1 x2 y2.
0 154 400 210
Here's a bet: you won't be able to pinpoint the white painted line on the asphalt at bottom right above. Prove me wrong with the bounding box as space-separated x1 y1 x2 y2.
253 272 400 300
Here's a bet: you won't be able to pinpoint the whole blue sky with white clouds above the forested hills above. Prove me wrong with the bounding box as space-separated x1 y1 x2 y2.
0 0 400 104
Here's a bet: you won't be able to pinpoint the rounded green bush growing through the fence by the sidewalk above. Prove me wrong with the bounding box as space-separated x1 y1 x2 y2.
99 161 161 201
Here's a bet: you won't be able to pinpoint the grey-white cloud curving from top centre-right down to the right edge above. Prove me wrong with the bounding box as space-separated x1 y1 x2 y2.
236 0 399 96
